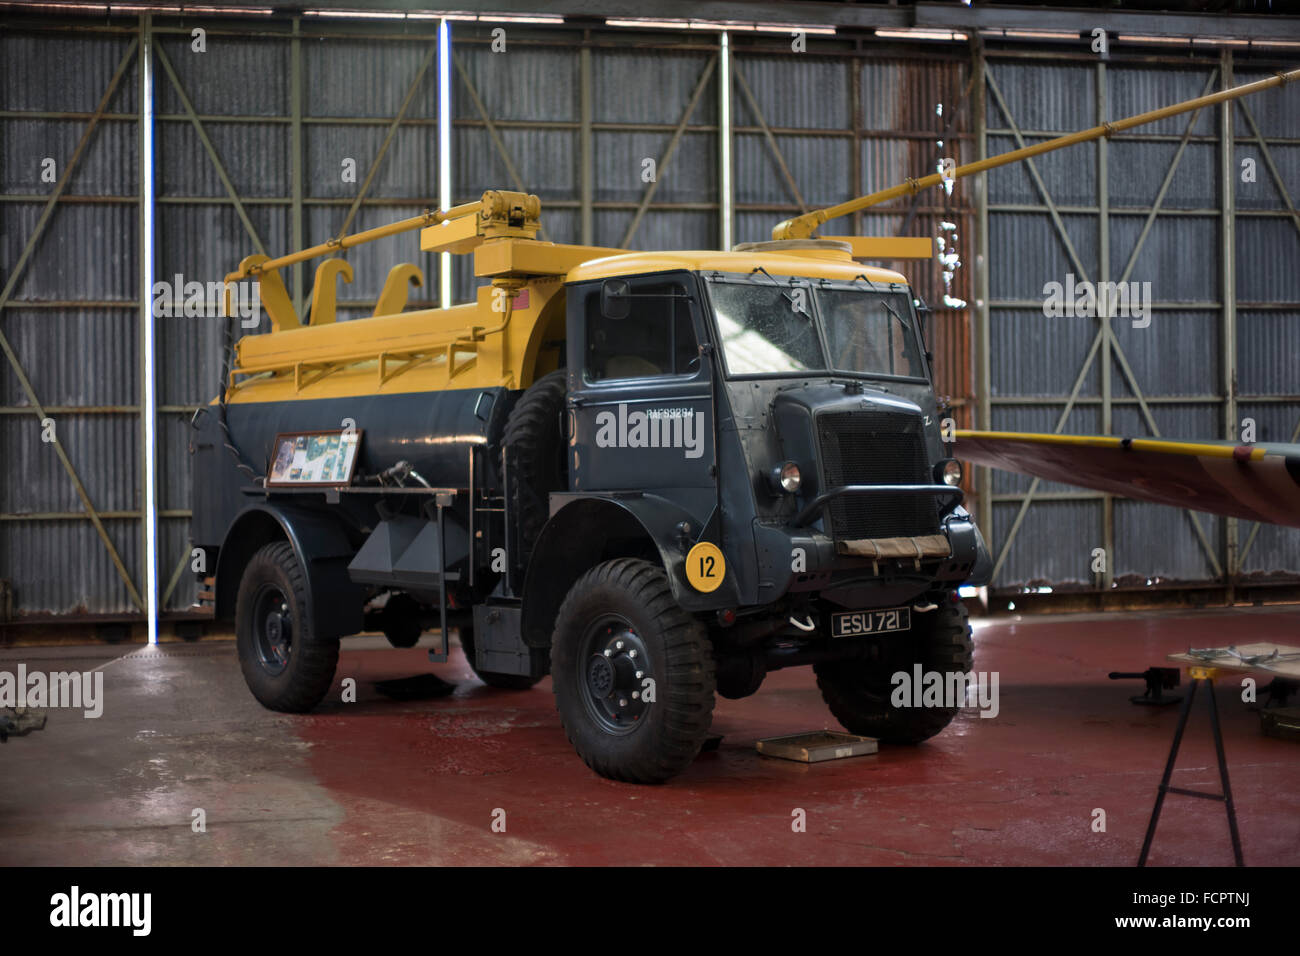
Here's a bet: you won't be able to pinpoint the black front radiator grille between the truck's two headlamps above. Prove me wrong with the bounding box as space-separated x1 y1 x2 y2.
816 411 939 541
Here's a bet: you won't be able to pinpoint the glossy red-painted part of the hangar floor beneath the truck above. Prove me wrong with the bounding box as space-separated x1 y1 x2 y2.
298 610 1300 865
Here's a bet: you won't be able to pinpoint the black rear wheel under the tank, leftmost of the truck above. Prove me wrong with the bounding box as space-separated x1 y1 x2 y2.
235 541 338 714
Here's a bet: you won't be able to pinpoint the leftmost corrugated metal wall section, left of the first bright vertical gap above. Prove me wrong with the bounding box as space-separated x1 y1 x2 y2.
0 33 144 614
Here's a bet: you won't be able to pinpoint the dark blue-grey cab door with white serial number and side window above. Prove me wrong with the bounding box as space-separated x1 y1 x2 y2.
568 272 716 515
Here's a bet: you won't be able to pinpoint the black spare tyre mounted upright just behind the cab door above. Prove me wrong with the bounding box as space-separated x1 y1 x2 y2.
503 368 568 559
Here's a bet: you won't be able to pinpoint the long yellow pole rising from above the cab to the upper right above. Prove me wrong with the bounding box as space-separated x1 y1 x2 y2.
772 69 1300 239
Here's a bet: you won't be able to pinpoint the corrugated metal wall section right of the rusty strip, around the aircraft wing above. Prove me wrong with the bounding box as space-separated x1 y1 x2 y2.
985 57 1300 589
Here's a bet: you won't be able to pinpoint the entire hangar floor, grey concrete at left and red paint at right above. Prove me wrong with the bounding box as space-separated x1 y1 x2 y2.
0 609 1300 865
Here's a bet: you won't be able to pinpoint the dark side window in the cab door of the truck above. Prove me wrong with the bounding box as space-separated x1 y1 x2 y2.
585 280 699 382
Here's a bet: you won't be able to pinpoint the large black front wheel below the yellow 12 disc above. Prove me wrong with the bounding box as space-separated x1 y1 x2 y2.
551 558 715 783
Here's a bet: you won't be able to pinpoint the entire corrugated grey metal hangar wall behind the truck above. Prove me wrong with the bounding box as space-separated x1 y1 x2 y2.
0 17 1300 624
